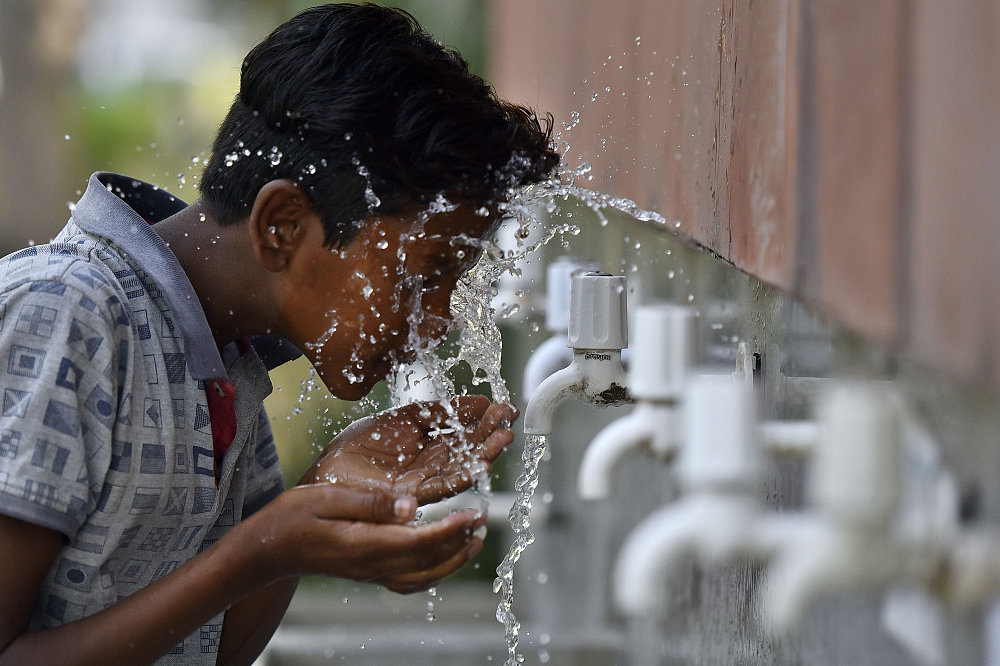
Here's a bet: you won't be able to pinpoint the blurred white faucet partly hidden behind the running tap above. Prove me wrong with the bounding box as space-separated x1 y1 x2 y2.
522 257 598 396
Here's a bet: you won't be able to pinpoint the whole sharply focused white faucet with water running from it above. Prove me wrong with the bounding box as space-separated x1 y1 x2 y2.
524 272 631 435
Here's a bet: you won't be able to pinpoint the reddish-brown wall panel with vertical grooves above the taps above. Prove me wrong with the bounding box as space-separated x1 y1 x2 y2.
490 0 1000 387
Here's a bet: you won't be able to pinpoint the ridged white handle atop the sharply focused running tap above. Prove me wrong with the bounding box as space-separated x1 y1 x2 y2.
568 272 628 350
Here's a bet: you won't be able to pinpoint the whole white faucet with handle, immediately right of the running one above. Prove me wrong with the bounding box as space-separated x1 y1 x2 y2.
578 305 697 500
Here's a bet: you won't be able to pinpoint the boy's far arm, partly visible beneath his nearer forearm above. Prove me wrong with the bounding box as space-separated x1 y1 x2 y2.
218 578 299 666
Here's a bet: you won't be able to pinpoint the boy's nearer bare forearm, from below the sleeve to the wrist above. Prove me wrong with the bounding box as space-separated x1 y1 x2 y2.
0 526 268 666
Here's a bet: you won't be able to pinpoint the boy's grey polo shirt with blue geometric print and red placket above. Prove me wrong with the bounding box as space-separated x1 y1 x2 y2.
0 174 294 664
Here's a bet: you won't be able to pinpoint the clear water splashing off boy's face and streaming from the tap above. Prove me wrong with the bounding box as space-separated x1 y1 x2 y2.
292 153 673 666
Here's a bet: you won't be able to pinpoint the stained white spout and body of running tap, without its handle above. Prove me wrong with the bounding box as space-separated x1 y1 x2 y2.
524 349 630 435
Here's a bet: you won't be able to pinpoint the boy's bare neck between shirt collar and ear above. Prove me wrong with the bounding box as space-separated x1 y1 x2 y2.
153 200 271 349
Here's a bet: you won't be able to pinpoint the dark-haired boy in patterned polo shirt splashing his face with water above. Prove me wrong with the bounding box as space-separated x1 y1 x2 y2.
0 5 558 666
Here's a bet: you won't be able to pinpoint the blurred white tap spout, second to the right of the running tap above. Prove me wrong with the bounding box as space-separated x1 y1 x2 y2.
615 494 759 616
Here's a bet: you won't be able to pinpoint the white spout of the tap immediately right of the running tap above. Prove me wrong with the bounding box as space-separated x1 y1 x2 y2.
577 402 678 500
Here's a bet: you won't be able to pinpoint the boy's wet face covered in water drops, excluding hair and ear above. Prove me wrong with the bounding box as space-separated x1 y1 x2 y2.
285 206 497 400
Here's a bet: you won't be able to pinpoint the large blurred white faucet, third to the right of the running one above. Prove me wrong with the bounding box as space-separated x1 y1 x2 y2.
766 382 937 632
